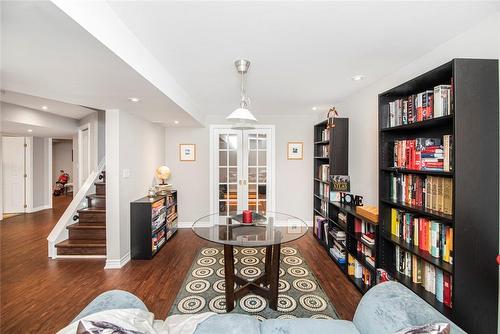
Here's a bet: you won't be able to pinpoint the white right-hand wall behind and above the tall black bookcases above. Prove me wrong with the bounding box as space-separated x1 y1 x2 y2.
335 12 500 205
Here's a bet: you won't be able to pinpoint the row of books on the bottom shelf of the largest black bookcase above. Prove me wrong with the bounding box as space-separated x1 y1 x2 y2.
395 246 453 307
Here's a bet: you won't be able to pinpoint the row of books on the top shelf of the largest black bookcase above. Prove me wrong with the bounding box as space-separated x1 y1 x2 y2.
386 85 453 127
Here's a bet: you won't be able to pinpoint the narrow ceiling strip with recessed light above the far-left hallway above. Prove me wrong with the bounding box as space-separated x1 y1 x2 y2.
0 90 95 119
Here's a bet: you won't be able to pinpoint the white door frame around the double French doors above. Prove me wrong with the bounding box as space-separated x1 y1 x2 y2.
210 124 276 213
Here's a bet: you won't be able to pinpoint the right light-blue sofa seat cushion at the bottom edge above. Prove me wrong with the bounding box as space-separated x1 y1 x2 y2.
260 319 359 334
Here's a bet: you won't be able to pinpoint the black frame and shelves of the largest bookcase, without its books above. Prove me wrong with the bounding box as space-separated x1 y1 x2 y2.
378 59 499 333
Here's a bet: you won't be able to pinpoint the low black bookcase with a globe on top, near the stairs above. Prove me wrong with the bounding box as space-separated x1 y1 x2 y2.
130 190 177 260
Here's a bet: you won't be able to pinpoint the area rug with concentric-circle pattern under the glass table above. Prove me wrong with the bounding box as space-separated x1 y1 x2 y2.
169 247 339 320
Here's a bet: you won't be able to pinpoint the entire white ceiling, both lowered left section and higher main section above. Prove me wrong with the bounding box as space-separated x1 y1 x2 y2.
1 0 500 126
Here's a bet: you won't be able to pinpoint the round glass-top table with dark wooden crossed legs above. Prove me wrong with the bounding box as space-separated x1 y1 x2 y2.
192 212 307 312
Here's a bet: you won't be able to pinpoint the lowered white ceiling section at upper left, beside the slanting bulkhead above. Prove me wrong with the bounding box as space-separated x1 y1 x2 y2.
0 1 199 126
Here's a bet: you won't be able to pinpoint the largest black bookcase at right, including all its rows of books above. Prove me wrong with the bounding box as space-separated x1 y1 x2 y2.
378 59 499 333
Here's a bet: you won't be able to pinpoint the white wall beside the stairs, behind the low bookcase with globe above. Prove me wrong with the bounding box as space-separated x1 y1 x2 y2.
106 110 165 268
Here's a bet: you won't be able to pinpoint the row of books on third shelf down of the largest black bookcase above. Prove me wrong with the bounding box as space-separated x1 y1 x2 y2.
390 174 453 215
